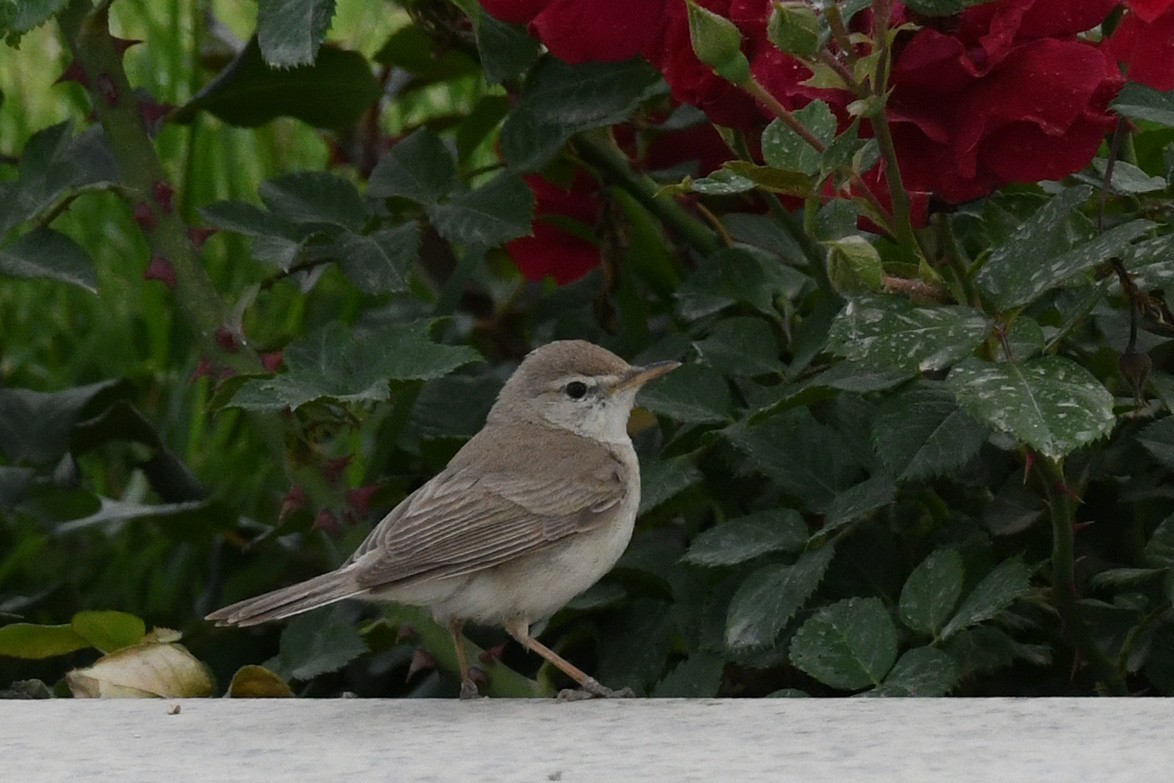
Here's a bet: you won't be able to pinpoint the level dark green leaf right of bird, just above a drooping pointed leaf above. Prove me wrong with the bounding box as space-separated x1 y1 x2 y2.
681 508 808 566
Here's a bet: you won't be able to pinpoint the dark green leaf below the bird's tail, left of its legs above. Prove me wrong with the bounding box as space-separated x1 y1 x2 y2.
265 609 367 681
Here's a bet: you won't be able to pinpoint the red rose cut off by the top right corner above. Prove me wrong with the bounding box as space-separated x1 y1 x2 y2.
1105 0 1174 90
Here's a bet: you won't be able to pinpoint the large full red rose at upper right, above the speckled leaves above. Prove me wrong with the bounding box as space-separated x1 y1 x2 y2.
889 11 1121 202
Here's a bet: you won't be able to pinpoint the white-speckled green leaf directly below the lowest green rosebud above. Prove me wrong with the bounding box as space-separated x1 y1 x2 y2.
828 296 991 372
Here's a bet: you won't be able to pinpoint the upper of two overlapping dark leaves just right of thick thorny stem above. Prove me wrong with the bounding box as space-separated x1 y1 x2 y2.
258 171 365 231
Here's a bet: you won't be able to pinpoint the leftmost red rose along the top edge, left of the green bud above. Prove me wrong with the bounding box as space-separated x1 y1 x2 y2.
481 0 662 63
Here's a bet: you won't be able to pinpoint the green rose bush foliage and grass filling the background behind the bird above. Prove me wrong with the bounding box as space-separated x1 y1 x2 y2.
0 0 1174 696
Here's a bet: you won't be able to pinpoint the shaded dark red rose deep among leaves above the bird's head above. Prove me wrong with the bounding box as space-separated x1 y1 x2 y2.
506 171 600 285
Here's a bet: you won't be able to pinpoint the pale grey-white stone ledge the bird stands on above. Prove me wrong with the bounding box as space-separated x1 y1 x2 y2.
0 698 1174 783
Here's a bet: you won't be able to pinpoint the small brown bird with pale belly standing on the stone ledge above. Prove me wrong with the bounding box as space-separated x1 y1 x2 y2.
208 340 679 697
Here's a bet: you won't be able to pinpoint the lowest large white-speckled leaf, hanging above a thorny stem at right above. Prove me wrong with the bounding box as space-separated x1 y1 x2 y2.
946 356 1116 459
